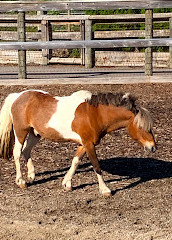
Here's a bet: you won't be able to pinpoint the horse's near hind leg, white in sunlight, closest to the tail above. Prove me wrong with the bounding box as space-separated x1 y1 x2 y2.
13 138 26 189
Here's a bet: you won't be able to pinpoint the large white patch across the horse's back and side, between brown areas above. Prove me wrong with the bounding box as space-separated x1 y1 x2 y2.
46 90 92 142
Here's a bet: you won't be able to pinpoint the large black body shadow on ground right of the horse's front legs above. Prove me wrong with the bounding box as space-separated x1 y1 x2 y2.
101 158 172 194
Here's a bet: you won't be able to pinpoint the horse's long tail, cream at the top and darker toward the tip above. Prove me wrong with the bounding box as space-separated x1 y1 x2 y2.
0 93 17 159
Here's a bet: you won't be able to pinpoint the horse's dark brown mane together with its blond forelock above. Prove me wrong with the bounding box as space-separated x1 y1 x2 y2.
88 92 153 131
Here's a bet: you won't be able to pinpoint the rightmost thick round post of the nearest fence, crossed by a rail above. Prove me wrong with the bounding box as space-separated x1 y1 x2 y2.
145 9 153 76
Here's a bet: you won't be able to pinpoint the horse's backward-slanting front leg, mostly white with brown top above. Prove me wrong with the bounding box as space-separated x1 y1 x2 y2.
62 146 85 191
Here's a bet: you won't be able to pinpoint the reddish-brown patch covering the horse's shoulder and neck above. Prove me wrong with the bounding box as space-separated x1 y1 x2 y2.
72 102 134 144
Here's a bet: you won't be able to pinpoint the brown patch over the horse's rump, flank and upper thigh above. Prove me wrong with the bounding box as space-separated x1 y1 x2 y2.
11 91 61 143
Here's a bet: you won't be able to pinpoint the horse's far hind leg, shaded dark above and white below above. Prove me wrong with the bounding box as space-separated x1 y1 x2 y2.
22 129 40 182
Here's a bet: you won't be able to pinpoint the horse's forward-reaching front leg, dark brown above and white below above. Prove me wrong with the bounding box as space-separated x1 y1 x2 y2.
85 143 111 197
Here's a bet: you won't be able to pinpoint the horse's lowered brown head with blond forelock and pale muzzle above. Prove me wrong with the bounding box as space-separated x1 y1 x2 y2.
128 108 156 152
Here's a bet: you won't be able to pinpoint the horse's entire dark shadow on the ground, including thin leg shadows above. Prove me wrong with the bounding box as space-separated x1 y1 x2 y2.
29 158 172 194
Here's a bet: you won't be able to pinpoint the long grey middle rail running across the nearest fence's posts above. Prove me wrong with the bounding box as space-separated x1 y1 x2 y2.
0 38 172 50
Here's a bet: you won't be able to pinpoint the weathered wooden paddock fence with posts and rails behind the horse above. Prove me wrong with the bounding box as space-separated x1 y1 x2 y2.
0 0 172 78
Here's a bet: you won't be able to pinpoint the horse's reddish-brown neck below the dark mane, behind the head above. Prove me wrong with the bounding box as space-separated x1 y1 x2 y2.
99 105 134 132
